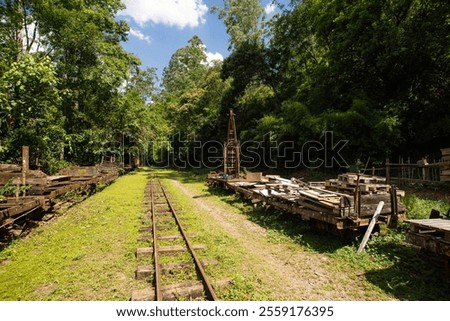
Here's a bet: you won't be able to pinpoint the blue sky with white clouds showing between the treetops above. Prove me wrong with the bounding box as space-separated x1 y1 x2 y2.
117 0 288 77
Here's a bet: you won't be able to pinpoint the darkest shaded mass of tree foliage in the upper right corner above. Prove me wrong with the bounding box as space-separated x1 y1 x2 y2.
270 0 450 159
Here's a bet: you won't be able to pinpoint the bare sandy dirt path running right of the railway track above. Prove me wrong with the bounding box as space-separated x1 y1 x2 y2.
172 180 395 301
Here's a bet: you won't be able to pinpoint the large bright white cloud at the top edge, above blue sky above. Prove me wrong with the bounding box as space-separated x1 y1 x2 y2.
119 0 208 29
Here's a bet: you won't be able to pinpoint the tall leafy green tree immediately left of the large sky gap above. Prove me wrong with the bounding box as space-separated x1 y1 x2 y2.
42 0 138 165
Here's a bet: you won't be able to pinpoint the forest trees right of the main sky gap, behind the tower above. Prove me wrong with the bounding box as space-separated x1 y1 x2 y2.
152 0 450 168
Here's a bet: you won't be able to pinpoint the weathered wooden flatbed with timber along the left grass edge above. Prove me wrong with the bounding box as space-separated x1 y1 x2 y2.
0 165 119 228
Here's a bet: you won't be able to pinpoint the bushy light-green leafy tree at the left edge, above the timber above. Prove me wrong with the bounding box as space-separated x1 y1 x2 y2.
0 55 67 170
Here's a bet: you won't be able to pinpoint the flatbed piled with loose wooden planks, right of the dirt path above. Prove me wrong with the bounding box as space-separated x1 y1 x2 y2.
208 172 405 230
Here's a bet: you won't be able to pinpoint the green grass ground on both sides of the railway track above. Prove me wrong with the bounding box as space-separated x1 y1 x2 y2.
0 170 450 300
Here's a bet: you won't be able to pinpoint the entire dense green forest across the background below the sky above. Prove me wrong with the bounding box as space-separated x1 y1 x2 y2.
0 0 450 173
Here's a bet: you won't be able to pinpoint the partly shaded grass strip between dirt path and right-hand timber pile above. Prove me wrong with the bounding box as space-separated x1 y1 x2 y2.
209 182 450 301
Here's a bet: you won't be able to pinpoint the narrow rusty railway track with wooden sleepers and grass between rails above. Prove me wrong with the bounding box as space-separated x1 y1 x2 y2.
132 179 217 301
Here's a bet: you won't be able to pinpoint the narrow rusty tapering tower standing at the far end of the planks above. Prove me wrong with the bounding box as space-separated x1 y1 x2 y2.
223 109 241 177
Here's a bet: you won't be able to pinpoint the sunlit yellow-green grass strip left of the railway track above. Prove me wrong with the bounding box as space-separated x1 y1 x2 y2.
0 172 147 301
